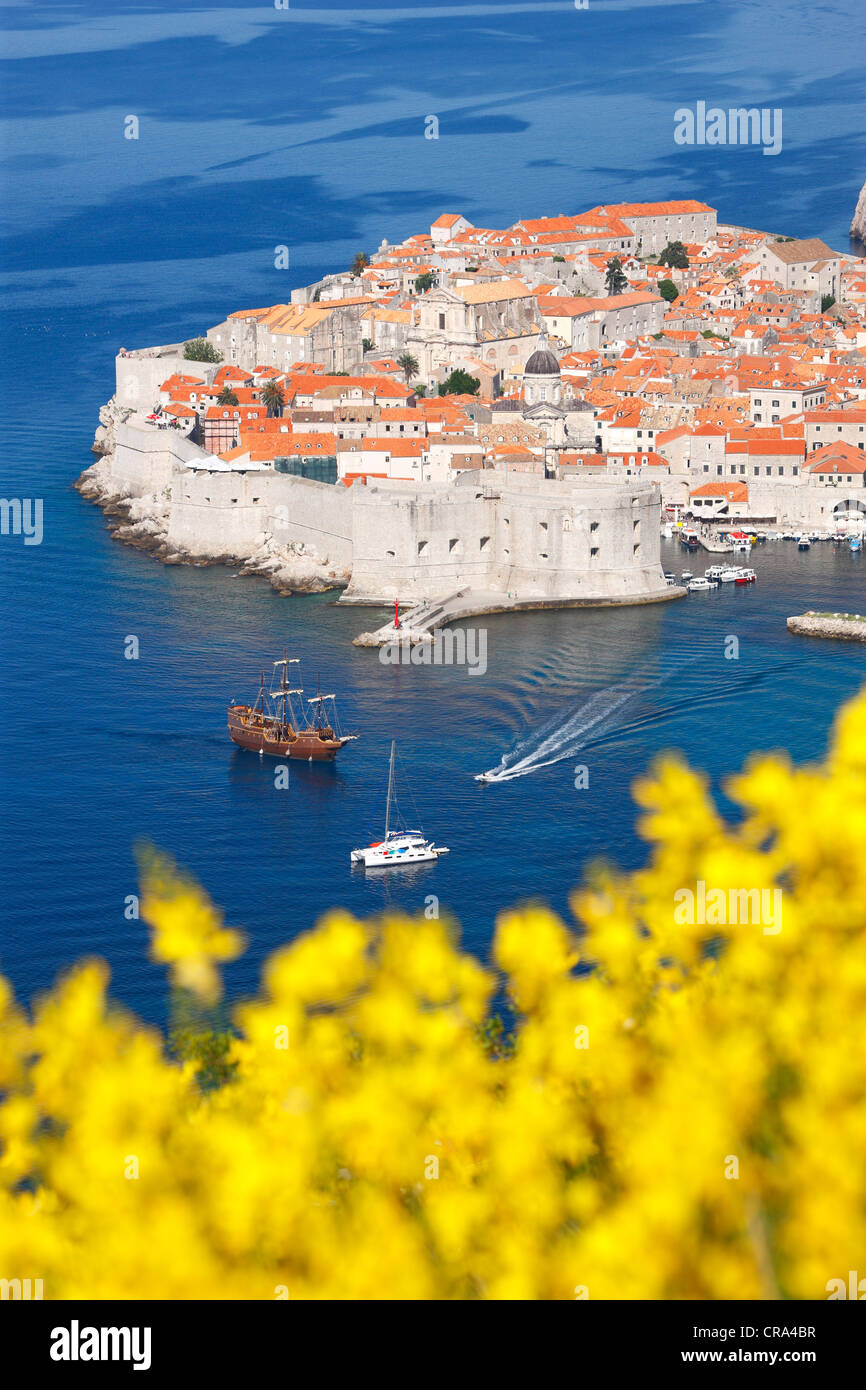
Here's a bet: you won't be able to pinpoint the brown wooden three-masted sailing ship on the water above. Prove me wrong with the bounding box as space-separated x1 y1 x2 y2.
228 652 359 763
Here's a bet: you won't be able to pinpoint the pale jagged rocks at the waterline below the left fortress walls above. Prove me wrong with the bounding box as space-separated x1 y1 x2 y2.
75 400 350 595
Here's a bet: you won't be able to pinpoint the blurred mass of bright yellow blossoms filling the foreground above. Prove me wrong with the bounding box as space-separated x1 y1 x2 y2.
0 698 866 1300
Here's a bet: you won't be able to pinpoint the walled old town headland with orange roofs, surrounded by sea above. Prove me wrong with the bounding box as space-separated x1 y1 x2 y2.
78 200 866 641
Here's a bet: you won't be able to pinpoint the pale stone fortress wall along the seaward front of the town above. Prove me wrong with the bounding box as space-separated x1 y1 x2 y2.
106 423 670 606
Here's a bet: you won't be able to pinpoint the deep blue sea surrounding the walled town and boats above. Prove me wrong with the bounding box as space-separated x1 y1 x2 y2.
0 0 866 1020
